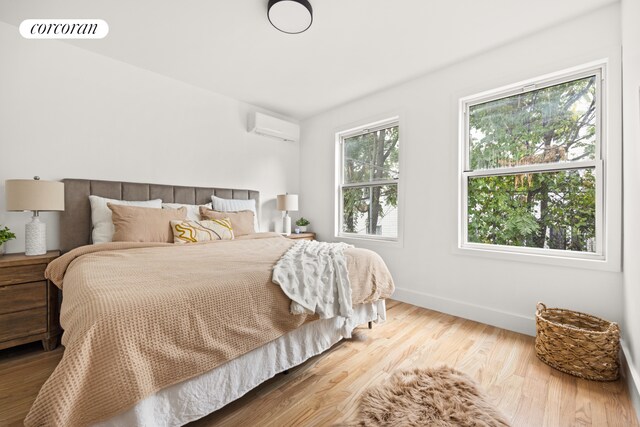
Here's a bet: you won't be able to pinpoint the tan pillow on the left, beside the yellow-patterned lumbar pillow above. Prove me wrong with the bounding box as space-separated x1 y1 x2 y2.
107 203 187 243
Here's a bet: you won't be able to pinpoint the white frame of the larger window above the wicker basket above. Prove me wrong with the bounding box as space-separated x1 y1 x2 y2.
458 62 607 264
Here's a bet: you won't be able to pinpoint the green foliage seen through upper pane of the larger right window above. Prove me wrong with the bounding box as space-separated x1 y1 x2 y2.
469 77 596 170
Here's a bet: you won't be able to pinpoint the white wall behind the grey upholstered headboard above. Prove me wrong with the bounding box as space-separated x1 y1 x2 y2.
0 22 299 252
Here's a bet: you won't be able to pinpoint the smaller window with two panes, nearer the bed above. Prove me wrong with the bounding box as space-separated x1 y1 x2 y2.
337 118 400 240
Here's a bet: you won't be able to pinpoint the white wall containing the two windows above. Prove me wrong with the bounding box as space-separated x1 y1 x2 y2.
300 4 622 334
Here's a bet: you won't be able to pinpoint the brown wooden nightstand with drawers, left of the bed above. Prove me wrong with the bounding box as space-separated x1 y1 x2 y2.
0 251 61 351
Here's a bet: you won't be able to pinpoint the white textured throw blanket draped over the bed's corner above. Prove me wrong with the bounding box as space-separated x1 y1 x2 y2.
273 240 353 335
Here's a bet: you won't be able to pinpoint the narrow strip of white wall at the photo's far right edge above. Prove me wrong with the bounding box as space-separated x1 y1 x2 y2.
621 0 640 418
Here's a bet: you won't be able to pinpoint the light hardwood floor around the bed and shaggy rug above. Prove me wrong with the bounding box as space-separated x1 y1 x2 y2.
0 301 638 427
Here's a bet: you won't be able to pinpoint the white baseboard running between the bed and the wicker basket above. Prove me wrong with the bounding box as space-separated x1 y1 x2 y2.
392 288 536 336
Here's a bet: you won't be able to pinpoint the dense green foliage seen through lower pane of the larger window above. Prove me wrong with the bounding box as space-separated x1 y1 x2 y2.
468 169 596 251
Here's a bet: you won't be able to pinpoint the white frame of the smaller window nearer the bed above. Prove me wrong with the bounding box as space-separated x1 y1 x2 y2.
334 115 403 244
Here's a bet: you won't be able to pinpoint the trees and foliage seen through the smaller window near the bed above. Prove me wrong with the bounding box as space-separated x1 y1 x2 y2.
342 126 399 234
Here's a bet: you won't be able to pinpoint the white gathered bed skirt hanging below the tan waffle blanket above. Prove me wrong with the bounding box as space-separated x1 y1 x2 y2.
96 300 386 427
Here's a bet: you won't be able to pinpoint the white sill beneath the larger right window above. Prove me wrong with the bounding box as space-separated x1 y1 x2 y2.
453 246 622 273
